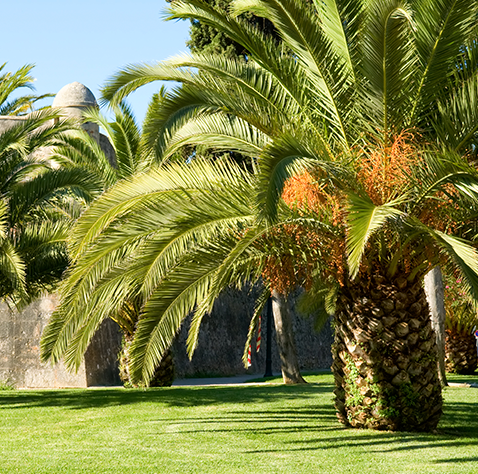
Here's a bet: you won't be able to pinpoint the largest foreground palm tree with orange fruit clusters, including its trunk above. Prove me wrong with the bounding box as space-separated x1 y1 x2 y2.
43 0 478 430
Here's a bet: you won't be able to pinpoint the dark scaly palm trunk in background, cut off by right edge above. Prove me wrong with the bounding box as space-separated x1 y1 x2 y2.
445 329 478 375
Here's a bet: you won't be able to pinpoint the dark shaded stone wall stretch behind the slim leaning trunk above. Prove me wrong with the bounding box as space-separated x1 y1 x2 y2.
173 290 333 378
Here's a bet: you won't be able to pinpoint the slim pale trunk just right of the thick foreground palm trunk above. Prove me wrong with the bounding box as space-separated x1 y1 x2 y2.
424 267 448 387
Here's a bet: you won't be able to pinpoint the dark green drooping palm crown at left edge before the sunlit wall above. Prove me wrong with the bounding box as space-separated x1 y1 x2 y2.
0 111 101 306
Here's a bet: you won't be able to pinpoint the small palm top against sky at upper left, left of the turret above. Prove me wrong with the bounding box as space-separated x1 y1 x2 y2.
0 63 52 115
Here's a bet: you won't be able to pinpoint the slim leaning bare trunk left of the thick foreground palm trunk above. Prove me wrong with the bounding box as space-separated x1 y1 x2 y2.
272 290 307 384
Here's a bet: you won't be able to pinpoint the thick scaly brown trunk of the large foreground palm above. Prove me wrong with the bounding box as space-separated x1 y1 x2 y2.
332 274 442 431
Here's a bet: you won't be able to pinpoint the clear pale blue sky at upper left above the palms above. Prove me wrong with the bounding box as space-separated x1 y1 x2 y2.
4 0 189 122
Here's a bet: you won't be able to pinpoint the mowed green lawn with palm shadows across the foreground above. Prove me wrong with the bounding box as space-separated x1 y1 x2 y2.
0 374 478 474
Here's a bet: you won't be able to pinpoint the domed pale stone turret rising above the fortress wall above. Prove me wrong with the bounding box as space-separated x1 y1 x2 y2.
52 82 100 143
